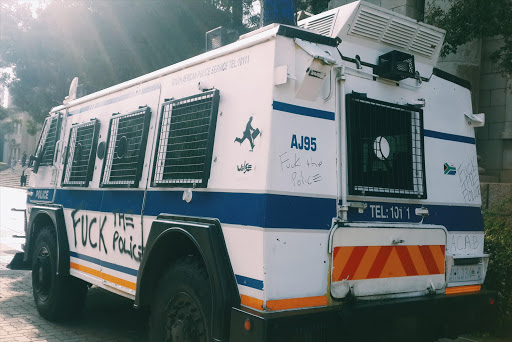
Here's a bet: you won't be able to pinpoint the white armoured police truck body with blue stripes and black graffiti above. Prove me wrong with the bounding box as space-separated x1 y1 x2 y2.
27 2 488 340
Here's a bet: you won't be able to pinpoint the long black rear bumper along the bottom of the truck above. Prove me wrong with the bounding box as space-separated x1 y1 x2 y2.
230 291 496 342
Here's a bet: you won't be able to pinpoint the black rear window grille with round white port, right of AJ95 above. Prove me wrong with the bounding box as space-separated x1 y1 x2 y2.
347 93 427 198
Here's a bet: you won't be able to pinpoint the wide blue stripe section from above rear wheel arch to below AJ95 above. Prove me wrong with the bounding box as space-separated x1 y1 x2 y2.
144 191 336 229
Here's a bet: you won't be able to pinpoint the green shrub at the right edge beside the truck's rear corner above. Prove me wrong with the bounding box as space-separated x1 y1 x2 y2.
484 197 512 324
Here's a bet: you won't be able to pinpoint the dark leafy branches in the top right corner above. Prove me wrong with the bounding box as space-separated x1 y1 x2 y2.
425 0 512 76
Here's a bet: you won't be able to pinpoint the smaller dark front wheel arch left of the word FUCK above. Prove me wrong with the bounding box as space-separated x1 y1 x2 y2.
24 206 69 274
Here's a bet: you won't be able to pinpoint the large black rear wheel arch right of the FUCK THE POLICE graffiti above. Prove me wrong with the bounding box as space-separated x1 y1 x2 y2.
135 215 240 340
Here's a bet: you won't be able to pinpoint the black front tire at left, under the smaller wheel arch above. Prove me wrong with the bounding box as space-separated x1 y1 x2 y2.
32 227 87 321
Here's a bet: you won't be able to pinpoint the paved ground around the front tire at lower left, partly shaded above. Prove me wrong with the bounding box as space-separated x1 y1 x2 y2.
0 270 148 342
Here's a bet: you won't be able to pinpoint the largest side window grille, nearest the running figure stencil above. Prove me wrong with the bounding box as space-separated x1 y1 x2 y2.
152 90 219 188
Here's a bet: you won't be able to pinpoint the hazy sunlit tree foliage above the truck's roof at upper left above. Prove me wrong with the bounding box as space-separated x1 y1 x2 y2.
0 0 234 122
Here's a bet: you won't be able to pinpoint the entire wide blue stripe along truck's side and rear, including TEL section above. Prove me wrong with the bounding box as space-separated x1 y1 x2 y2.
31 189 484 231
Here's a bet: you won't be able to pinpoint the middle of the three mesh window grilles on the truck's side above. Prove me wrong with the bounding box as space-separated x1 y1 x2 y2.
101 107 151 187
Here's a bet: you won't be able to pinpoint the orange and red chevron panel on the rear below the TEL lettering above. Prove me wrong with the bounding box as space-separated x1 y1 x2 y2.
332 245 445 282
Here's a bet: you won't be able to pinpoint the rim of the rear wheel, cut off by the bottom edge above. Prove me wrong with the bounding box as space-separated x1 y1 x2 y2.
165 292 206 342
